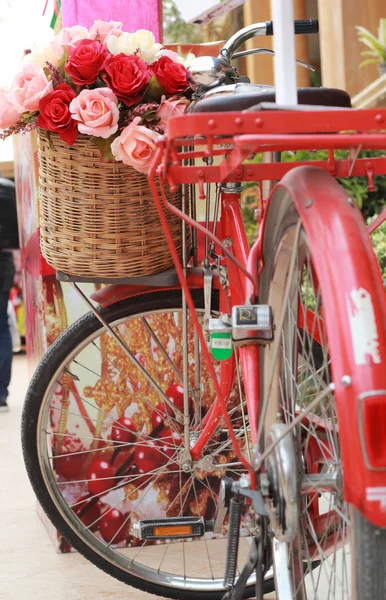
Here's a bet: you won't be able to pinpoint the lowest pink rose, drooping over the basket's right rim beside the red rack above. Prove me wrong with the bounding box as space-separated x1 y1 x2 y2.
111 117 160 175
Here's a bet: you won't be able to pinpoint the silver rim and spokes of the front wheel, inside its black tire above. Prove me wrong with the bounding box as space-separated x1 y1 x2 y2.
30 292 260 594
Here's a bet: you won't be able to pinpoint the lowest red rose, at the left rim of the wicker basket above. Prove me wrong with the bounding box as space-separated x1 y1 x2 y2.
38 83 78 146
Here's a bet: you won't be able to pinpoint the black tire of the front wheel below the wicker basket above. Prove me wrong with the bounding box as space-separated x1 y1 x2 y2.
22 291 273 600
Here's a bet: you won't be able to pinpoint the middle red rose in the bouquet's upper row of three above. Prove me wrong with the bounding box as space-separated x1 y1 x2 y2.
102 53 150 106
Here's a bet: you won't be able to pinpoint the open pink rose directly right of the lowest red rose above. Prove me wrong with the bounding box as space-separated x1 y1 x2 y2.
70 88 119 139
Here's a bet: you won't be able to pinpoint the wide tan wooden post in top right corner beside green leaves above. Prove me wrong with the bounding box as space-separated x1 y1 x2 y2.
318 0 386 95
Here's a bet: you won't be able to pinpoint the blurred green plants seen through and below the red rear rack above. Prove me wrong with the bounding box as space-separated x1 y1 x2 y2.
242 150 386 281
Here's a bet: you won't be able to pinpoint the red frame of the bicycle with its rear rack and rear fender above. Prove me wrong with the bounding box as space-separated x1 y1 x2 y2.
93 109 386 526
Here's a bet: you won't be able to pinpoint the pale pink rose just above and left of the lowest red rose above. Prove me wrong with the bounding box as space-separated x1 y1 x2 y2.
10 64 54 113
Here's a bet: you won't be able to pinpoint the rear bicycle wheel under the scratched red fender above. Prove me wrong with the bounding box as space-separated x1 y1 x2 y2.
260 185 386 600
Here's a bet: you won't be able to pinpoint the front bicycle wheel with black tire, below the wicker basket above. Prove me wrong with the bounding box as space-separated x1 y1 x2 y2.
22 291 273 600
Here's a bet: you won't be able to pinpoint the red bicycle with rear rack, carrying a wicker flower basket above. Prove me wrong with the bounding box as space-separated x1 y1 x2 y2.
23 16 386 600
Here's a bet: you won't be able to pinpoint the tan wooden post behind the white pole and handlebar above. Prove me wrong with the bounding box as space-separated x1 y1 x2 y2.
244 0 311 87
